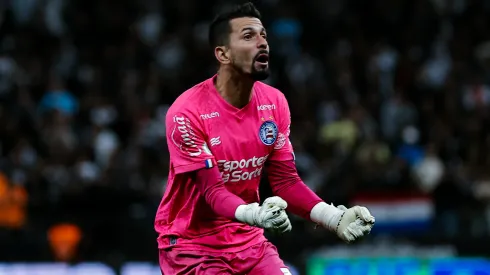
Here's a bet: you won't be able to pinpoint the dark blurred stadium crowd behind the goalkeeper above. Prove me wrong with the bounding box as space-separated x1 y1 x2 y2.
0 0 490 270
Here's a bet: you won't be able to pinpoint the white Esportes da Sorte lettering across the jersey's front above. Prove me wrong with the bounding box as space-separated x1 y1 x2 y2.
218 155 269 182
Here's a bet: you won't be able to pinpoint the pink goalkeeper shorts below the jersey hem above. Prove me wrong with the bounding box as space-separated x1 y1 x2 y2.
159 242 290 275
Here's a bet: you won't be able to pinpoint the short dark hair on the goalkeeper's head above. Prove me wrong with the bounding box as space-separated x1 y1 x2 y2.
209 2 261 48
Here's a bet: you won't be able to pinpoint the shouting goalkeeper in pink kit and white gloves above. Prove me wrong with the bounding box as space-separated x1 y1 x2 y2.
155 3 374 275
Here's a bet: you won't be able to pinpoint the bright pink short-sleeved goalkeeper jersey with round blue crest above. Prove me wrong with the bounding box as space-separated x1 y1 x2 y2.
155 77 294 252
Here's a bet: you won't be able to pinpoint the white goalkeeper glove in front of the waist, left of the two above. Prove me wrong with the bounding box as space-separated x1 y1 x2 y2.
235 197 292 233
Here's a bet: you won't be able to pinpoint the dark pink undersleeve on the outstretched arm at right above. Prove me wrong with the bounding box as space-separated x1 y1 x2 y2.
267 160 322 220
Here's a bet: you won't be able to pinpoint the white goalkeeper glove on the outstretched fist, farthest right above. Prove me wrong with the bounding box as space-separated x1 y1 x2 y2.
310 202 375 243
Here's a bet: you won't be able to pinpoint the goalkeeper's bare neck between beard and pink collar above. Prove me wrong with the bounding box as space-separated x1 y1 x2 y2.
215 67 255 108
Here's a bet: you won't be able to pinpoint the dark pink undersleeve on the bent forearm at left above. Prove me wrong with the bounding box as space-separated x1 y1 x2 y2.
196 166 246 220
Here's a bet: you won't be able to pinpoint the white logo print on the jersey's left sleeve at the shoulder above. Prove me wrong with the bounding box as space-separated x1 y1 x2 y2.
171 116 202 157
